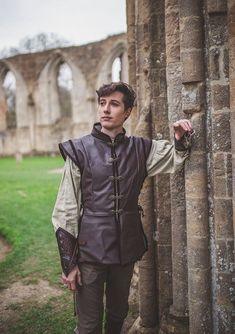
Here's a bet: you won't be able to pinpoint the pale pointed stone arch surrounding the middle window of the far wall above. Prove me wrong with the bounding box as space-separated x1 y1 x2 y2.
35 50 90 151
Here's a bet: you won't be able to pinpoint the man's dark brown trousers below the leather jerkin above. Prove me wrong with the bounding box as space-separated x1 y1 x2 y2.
75 263 134 334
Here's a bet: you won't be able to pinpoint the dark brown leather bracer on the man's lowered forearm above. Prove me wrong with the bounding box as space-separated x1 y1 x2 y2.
56 227 78 276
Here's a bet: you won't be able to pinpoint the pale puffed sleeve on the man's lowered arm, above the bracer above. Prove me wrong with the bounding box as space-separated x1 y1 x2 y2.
52 157 81 237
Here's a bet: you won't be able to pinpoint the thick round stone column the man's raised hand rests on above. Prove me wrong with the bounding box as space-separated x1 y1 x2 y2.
180 0 212 334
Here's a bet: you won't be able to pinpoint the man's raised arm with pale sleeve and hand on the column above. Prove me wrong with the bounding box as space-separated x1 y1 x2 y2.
146 120 193 176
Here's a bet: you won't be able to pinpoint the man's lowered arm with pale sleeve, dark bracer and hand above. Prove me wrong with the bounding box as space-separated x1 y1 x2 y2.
52 157 81 290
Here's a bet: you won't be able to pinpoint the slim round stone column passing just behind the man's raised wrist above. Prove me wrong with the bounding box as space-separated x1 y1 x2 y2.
165 0 188 333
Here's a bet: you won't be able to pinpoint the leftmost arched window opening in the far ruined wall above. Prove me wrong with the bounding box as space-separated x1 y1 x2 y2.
3 71 16 129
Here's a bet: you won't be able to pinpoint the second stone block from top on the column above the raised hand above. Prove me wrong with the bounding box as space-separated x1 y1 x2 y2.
180 17 203 49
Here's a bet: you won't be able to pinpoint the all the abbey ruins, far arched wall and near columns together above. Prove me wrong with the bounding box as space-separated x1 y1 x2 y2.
0 0 235 334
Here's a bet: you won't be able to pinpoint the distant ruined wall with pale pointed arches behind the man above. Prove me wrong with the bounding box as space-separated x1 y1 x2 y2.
0 34 128 156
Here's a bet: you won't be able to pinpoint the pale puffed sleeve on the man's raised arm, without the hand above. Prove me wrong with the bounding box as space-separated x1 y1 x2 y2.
146 138 191 176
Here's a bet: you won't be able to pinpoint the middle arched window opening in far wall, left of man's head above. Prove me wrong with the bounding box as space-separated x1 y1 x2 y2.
57 63 73 117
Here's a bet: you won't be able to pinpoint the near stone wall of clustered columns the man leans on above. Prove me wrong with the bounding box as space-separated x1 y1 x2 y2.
127 0 235 334
